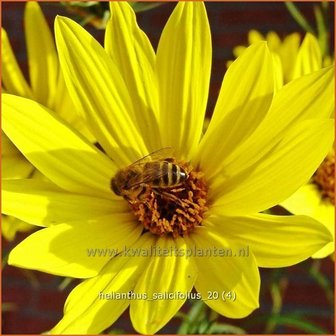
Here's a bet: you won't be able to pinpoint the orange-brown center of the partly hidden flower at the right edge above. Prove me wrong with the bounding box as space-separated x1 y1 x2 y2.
313 154 335 204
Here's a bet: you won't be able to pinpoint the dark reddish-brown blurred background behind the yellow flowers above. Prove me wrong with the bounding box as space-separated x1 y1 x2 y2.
2 2 334 334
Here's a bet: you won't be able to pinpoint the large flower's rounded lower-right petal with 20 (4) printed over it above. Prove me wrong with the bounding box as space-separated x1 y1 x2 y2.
187 227 260 318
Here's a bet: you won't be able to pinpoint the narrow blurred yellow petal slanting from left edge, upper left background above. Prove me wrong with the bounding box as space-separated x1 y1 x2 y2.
1 28 32 98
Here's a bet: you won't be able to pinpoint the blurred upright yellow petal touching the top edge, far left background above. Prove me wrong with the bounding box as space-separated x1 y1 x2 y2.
24 1 58 106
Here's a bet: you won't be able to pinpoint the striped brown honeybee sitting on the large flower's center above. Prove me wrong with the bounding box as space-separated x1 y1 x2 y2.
111 147 189 204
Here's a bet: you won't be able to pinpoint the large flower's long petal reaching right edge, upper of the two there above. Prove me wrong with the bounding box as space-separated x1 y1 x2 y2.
213 67 334 194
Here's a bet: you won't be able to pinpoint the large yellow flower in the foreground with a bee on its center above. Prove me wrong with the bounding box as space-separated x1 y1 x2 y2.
3 2 334 334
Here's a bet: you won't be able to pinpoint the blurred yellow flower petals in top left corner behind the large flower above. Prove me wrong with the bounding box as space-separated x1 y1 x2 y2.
1 1 92 140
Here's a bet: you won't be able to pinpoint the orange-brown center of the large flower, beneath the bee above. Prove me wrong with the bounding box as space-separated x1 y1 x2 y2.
129 162 207 238
